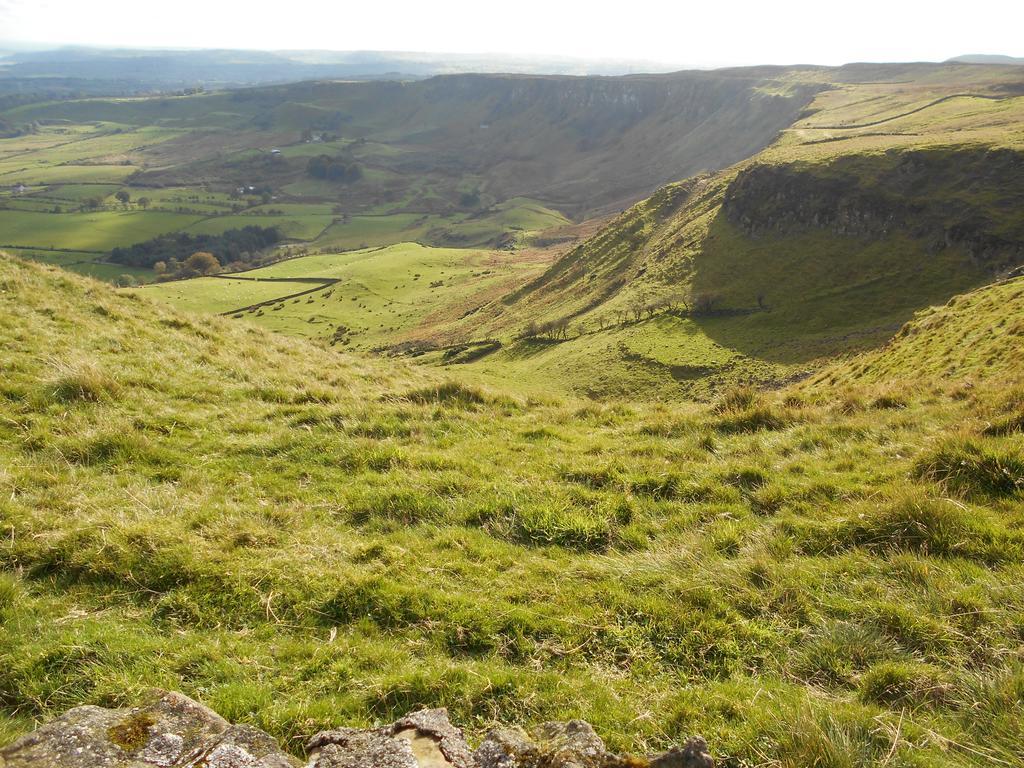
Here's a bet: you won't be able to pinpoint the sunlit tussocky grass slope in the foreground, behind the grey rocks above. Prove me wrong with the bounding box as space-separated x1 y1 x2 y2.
0 258 1024 766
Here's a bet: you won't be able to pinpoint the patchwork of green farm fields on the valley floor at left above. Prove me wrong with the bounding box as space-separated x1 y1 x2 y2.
0 114 568 280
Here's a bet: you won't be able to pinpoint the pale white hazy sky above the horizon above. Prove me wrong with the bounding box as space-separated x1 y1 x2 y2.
0 0 1024 66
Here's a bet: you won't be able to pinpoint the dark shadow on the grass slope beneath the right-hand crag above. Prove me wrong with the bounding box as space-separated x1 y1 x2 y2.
693 211 991 365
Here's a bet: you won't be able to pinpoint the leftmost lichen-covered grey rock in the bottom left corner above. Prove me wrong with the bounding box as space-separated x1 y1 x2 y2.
0 691 298 768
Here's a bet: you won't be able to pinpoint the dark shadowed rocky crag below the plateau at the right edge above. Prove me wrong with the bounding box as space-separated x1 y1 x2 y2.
722 150 1024 274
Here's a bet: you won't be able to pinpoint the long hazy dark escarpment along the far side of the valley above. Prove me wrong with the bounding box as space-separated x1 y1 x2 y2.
8 68 825 216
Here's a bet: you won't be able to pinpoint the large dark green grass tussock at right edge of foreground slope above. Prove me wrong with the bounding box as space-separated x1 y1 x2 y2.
913 439 1024 497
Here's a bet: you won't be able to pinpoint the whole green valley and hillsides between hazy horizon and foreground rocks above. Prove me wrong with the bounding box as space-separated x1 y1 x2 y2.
0 55 1024 768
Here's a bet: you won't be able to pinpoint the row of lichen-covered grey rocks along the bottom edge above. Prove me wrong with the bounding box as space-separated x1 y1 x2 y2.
0 691 715 768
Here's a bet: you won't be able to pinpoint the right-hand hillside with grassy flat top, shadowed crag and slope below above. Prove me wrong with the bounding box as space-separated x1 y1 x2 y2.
434 67 1024 398
